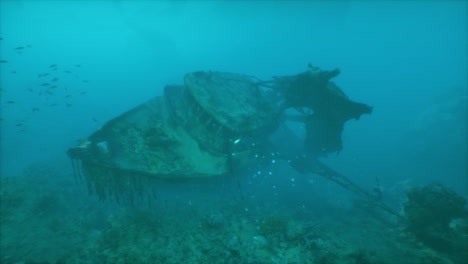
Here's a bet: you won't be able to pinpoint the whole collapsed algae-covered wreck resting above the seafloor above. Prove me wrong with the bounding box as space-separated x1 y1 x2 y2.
68 65 393 217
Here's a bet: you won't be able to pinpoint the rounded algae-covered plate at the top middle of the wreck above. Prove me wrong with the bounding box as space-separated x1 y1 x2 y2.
185 72 280 134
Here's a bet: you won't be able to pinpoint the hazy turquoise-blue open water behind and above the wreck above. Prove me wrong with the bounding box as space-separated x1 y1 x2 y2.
0 0 468 262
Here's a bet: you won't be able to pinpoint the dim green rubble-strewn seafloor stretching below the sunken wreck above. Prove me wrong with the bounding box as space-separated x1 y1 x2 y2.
0 164 468 264
